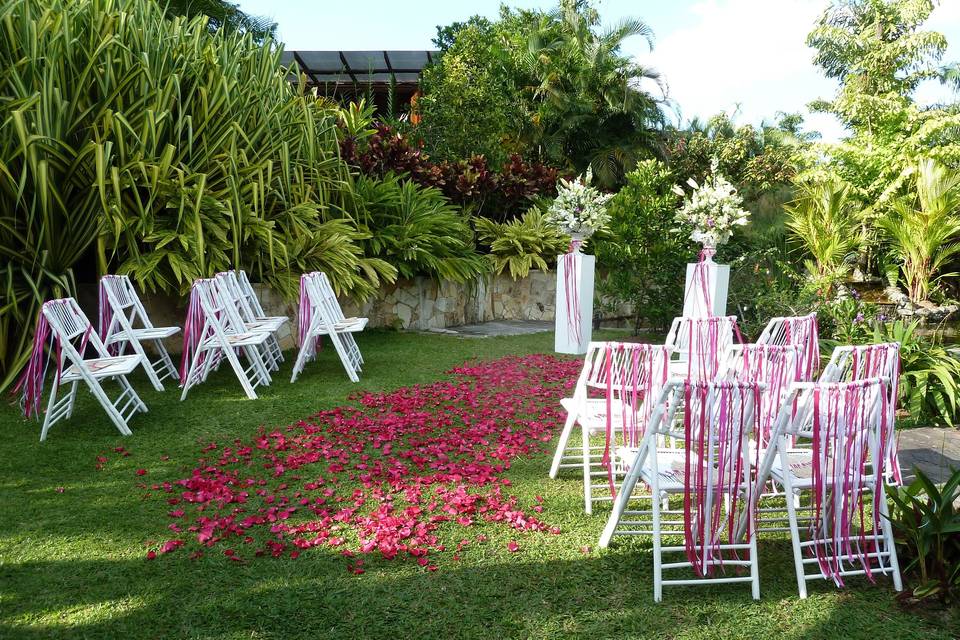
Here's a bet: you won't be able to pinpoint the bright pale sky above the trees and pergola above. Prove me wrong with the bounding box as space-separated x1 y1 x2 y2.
239 0 960 140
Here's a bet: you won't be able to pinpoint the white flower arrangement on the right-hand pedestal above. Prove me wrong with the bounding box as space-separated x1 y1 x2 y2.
673 160 750 247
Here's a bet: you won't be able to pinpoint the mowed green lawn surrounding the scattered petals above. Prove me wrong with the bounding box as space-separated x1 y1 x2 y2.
0 332 960 640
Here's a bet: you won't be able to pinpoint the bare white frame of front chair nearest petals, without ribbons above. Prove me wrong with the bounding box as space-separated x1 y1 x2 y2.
599 380 762 602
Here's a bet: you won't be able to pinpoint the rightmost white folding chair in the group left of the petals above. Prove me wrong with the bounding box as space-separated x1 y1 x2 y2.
290 271 367 382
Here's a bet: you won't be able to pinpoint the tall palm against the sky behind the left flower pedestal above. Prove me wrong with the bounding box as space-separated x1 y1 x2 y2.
522 0 666 187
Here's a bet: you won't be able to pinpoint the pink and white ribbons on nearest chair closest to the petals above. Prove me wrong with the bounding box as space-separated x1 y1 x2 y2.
683 380 759 577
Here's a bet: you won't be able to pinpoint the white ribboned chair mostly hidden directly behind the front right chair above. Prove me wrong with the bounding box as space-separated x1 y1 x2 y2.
820 342 903 485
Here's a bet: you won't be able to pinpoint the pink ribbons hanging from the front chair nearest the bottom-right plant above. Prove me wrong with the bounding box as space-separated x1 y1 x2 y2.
811 382 889 587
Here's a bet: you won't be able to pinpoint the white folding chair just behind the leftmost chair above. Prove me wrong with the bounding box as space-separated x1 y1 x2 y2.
100 275 180 391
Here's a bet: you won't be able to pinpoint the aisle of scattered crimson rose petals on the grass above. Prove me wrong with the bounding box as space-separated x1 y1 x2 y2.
148 355 580 573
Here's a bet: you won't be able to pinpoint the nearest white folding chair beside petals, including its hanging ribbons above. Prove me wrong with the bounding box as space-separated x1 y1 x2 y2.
599 380 762 602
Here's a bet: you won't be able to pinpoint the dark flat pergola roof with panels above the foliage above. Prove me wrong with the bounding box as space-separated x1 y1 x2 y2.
281 50 439 84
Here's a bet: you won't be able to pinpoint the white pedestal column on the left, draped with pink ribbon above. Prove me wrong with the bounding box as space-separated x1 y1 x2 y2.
554 251 597 354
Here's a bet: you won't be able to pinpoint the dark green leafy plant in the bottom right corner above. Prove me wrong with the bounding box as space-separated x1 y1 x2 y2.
887 468 960 603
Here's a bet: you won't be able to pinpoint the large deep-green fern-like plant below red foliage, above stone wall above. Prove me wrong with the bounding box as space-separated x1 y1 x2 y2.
355 174 487 282
